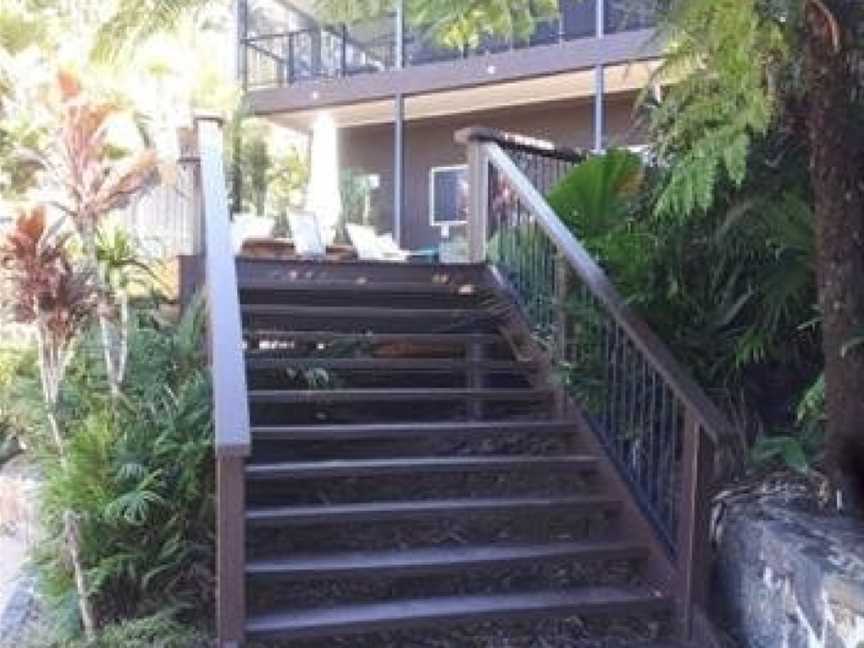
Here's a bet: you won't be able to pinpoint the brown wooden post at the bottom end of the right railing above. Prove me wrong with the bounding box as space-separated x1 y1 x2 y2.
677 409 715 639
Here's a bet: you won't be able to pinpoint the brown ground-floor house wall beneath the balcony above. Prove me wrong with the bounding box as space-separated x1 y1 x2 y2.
340 98 640 249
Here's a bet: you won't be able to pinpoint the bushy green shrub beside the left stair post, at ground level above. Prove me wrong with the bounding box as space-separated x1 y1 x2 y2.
38 307 214 645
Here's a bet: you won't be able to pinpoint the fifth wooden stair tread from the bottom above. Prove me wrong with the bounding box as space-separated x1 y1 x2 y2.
252 419 576 440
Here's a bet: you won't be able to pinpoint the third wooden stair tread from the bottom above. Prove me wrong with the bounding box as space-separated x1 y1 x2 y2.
246 495 620 524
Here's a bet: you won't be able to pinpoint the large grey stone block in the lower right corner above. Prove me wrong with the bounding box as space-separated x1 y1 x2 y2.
714 495 864 648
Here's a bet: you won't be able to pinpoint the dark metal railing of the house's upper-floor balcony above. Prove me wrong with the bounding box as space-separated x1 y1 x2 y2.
240 0 656 89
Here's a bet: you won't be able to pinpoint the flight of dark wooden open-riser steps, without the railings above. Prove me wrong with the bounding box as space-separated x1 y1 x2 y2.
240 260 670 646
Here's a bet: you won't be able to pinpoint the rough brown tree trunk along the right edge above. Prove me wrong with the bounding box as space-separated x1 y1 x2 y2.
806 0 864 512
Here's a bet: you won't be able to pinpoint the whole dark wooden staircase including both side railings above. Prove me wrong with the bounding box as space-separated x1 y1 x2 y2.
194 118 732 648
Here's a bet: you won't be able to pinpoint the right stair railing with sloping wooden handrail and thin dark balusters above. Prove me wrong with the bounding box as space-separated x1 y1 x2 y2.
456 128 731 638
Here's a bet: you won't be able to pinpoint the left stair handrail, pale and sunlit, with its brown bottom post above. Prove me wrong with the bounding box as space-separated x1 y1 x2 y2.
196 117 251 648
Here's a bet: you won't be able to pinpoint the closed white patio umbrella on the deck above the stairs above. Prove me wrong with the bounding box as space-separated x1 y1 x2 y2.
306 113 342 245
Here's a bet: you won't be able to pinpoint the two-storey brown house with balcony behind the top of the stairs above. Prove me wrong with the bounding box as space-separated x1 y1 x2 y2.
238 0 661 249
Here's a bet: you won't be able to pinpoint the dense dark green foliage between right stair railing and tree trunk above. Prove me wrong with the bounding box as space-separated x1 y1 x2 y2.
548 132 820 436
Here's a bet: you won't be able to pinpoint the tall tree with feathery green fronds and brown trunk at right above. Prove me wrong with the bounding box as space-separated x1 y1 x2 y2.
651 0 864 512
